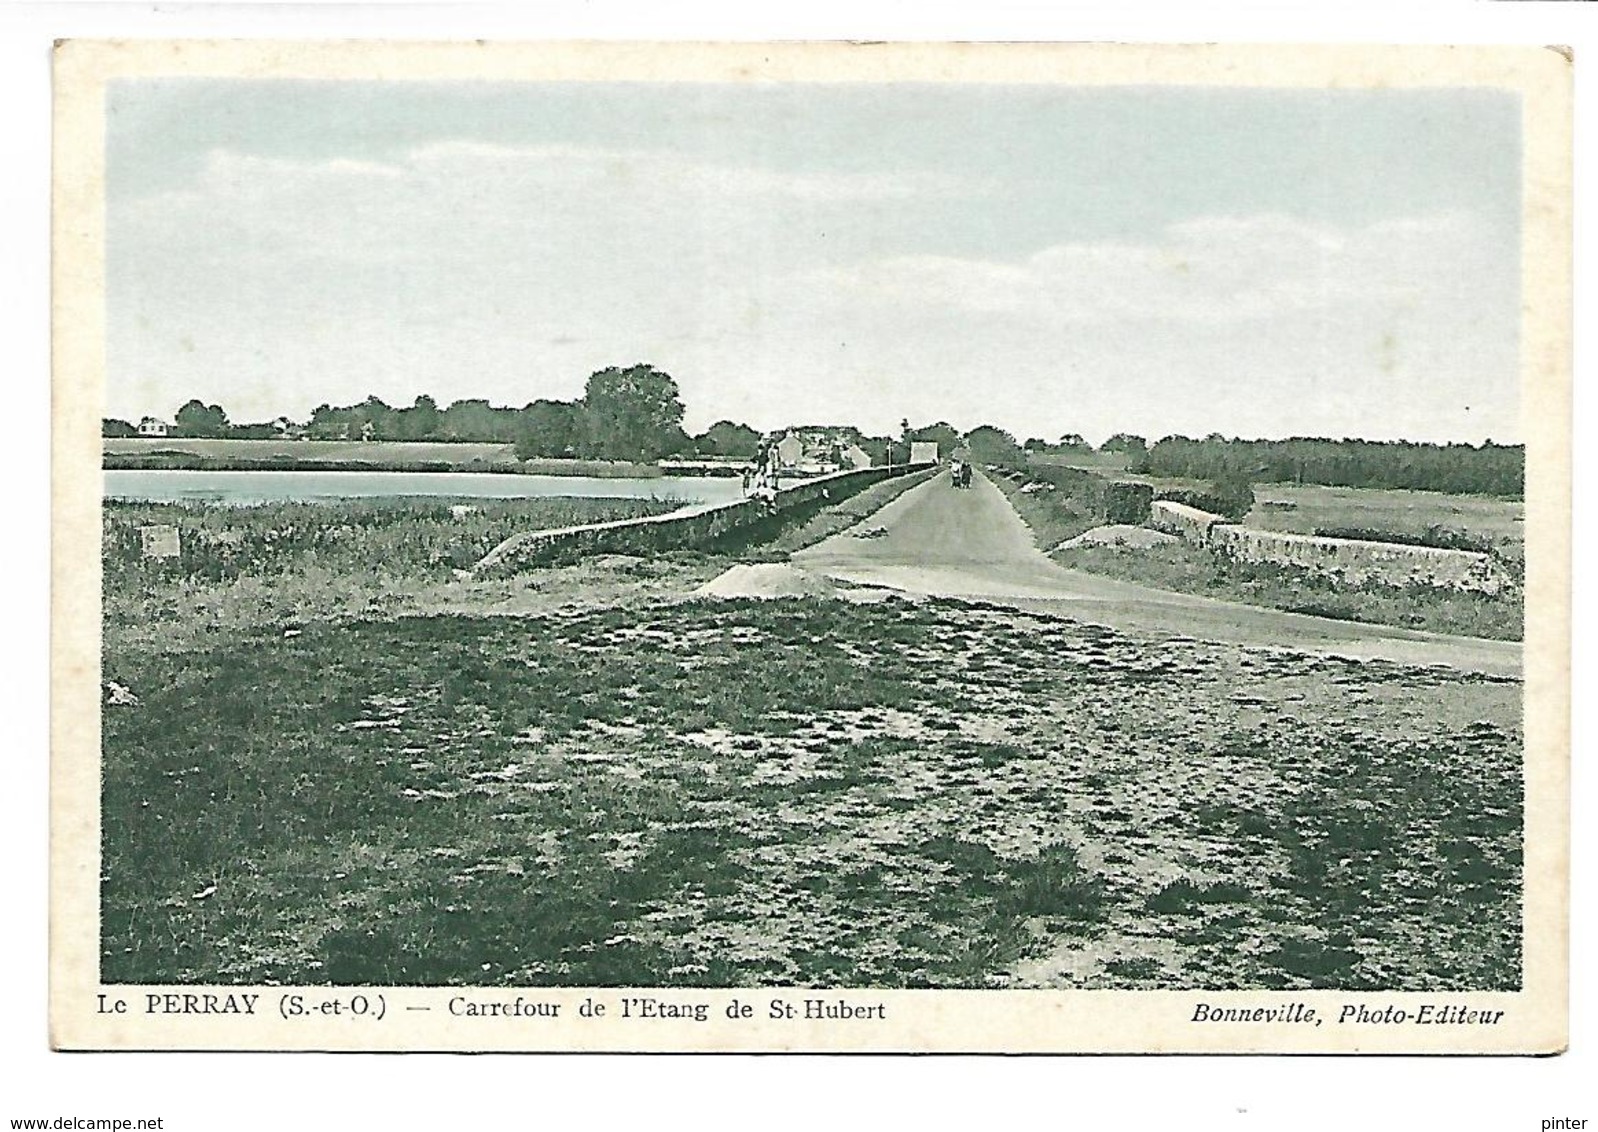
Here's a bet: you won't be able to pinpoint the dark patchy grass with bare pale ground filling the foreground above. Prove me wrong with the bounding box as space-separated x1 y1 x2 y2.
101 600 1521 990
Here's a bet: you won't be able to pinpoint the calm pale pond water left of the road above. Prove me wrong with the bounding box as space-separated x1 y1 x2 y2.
104 468 743 505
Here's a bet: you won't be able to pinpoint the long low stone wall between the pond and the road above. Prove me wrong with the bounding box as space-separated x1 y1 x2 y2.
471 464 927 577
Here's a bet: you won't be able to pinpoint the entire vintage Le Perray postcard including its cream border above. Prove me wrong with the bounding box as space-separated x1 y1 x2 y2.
50 42 1572 1054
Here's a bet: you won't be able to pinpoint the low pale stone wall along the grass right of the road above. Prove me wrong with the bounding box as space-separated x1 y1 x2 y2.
1151 499 1515 595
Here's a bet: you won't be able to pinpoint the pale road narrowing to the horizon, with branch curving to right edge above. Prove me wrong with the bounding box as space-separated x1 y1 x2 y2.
793 473 1521 676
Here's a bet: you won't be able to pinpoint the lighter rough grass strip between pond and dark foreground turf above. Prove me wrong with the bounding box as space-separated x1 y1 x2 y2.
101 497 678 665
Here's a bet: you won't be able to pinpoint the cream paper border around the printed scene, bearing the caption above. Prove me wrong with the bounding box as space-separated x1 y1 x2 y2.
51 42 1571 1054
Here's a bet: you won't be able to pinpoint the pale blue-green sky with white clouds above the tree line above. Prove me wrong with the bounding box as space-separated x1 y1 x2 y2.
105 78 1521 443
